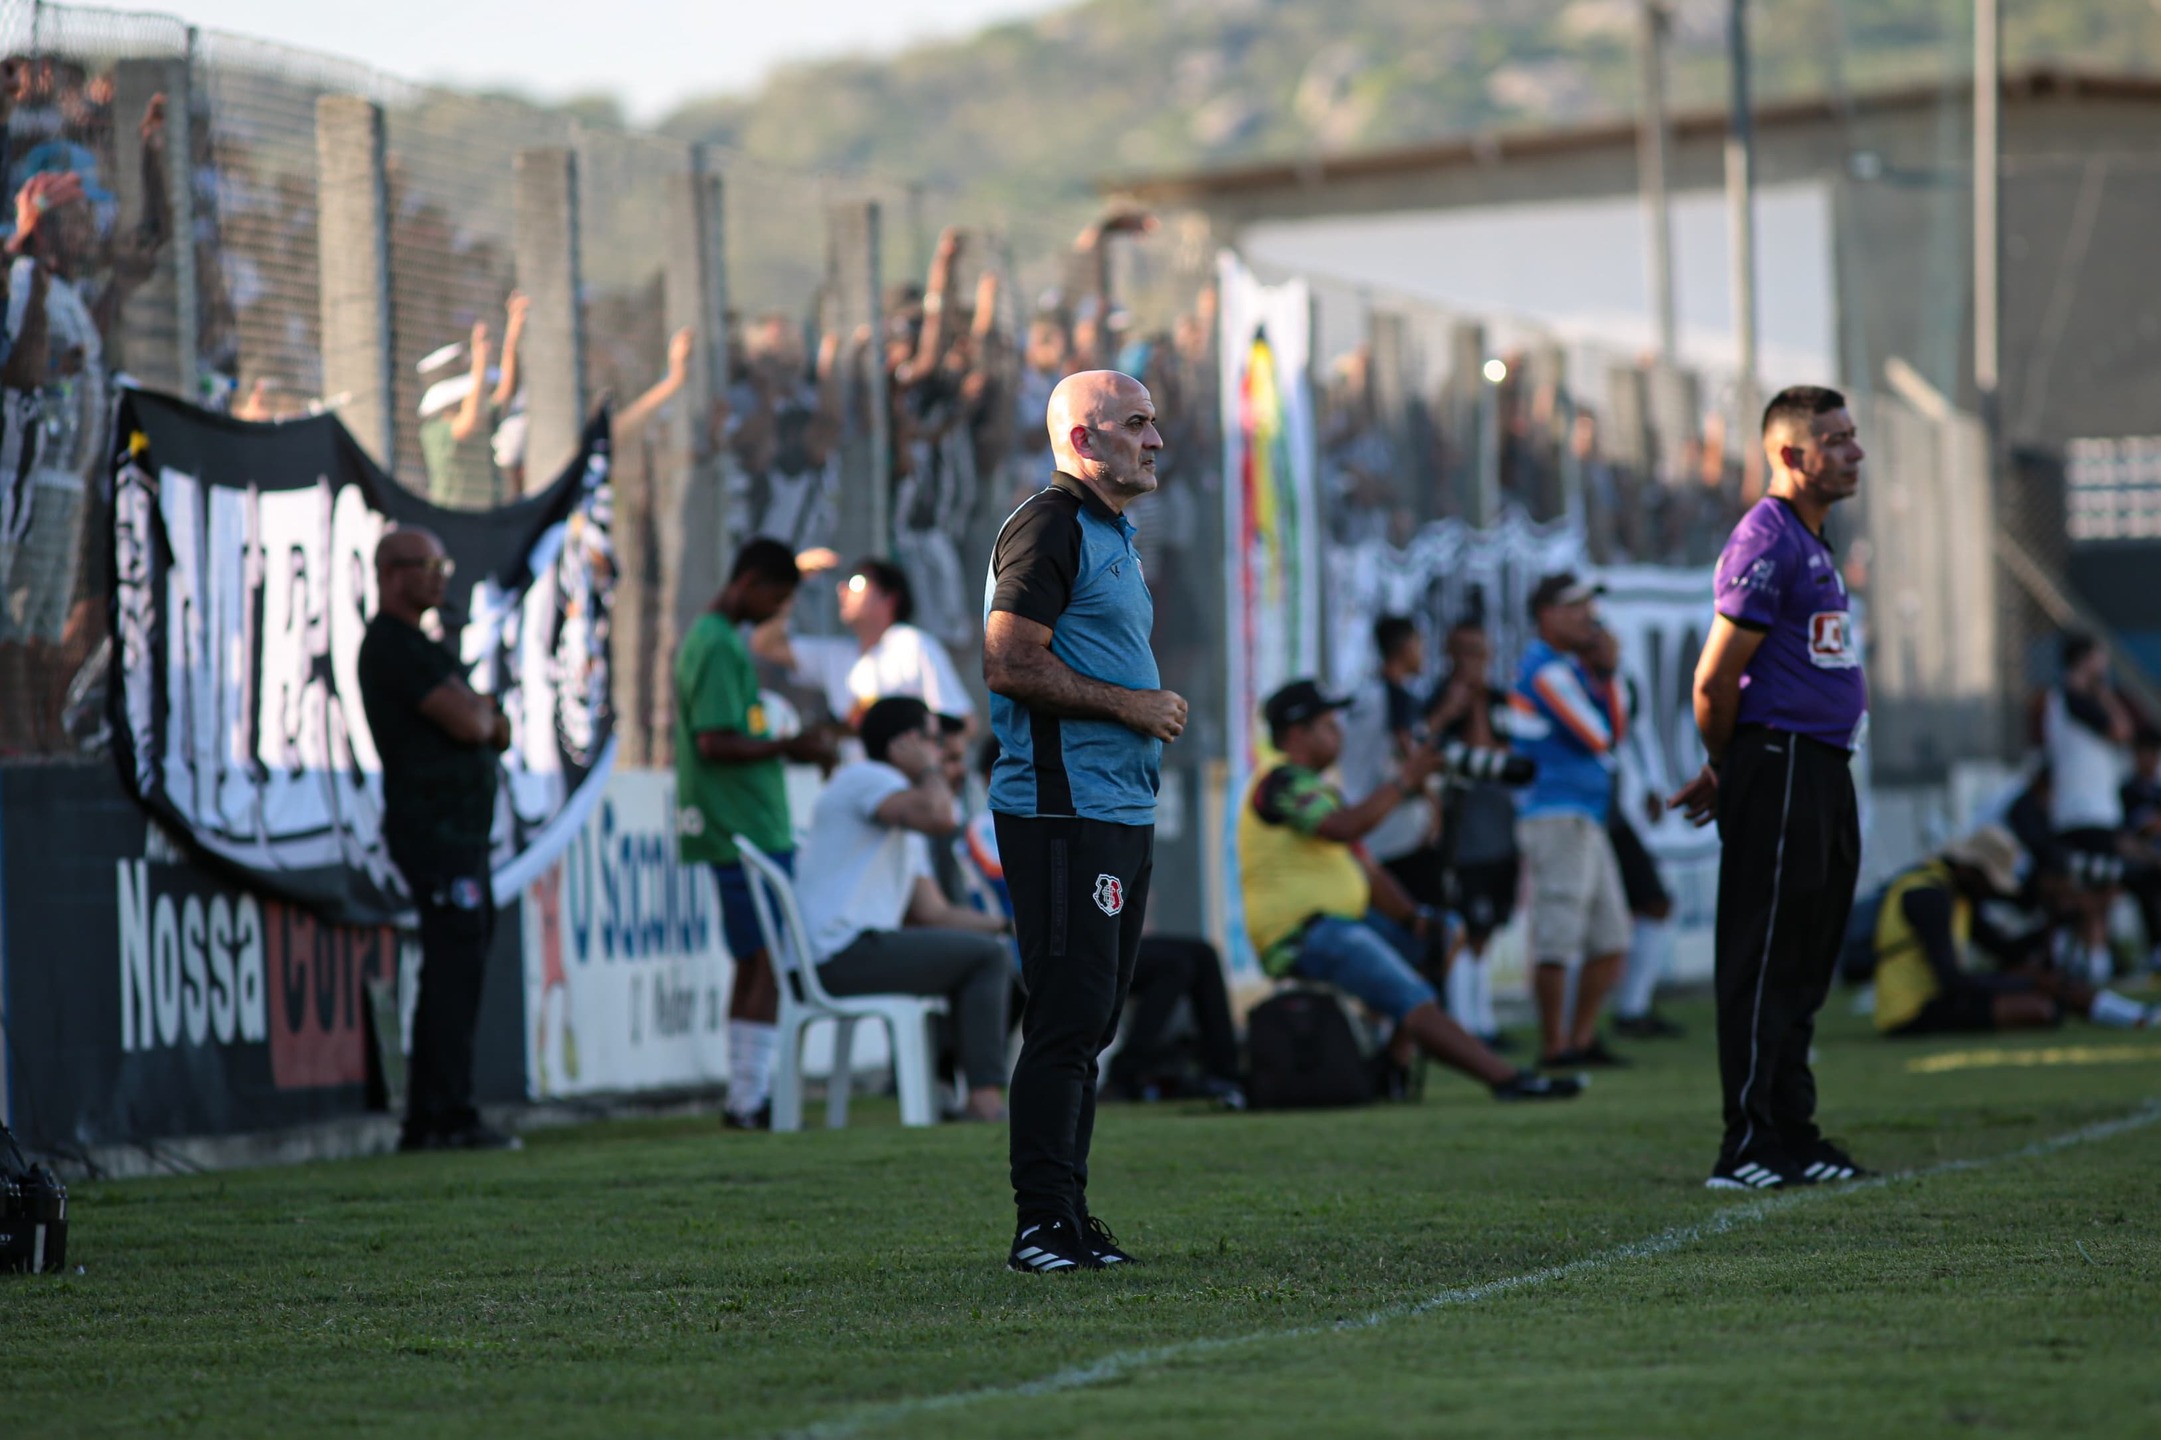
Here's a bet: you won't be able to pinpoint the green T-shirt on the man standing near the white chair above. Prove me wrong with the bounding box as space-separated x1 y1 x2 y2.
676 612 795 865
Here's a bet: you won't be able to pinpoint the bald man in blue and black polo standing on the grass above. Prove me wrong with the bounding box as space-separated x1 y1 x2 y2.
983 370 1186 1274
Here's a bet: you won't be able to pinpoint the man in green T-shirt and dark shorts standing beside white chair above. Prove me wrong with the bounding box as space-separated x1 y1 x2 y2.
674 538 836 1129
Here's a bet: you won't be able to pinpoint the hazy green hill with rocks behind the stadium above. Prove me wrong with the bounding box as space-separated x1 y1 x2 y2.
666 0 2161 263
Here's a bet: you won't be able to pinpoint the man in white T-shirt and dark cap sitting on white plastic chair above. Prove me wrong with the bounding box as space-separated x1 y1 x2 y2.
795 696 1011 1120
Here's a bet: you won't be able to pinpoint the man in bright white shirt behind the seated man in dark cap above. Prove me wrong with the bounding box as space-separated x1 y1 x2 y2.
752 549 975 729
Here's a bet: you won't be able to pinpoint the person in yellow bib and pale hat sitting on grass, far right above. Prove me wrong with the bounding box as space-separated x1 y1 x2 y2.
1876 826 2155 1036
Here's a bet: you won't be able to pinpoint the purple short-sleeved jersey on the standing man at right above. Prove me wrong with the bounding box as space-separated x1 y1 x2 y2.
1718 497 1869 750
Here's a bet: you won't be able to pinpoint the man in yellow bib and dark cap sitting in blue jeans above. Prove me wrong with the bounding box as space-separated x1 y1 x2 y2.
1238 679 1582 1101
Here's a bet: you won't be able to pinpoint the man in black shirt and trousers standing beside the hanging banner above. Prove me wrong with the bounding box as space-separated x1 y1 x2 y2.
359 530 516 1150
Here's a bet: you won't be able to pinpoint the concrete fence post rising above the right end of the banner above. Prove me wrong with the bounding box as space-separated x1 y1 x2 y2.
512 147 586 489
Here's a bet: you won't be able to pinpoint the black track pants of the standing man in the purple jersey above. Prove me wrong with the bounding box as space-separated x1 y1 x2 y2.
1718 726 1861 1159
